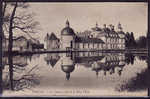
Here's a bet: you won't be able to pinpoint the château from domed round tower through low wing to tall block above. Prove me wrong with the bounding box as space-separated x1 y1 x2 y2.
61 20 125 50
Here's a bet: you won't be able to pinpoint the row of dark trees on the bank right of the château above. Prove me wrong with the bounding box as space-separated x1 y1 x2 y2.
125 32 147 49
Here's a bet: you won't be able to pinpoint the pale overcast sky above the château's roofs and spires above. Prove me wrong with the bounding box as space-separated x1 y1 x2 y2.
26 2 148 42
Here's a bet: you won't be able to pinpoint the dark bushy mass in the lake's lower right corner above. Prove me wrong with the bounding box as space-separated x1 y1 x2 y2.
116 56 150 91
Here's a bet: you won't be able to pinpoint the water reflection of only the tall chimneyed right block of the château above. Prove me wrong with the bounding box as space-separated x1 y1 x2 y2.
92 54 125 75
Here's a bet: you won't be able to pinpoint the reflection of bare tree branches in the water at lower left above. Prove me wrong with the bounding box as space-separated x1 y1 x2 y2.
3 55 39 91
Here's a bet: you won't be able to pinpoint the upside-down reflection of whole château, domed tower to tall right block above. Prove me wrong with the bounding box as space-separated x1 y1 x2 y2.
61 52 125 80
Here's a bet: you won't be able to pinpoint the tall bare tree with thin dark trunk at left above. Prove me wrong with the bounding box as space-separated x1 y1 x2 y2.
3 2 39 90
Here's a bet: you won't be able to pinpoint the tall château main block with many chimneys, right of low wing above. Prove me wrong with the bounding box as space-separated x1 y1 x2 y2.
92 23 125 49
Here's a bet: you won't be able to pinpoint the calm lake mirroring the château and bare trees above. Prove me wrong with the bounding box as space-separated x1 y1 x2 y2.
3 52 149 97
